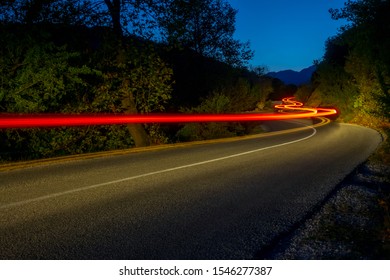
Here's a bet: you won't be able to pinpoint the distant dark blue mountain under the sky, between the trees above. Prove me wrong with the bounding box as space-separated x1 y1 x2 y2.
266 65 317 86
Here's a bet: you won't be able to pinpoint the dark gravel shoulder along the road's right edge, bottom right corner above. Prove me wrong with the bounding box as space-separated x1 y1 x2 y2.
262 158 390 260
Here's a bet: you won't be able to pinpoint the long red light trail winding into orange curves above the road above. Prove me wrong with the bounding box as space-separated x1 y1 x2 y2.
0 97 337 129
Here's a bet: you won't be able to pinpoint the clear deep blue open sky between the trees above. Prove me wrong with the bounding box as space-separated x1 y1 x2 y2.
227 0 345 71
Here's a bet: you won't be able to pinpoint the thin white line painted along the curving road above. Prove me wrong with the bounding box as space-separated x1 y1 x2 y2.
0 125 317 209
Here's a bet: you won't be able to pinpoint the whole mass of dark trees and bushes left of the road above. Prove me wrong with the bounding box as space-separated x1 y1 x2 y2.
0 0 277 162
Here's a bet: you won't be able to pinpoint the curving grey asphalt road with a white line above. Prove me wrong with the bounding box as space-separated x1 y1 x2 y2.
0 119 381 259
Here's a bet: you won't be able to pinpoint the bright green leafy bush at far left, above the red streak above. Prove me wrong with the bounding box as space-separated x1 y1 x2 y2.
0 44 99 113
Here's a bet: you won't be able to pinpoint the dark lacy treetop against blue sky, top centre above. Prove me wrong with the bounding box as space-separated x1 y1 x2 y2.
155 0 253 66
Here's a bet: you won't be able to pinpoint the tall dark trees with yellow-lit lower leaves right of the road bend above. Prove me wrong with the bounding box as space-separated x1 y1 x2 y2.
309 0 390 126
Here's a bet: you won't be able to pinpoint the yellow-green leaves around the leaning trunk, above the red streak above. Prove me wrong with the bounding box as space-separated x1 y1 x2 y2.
95 40 173 113
